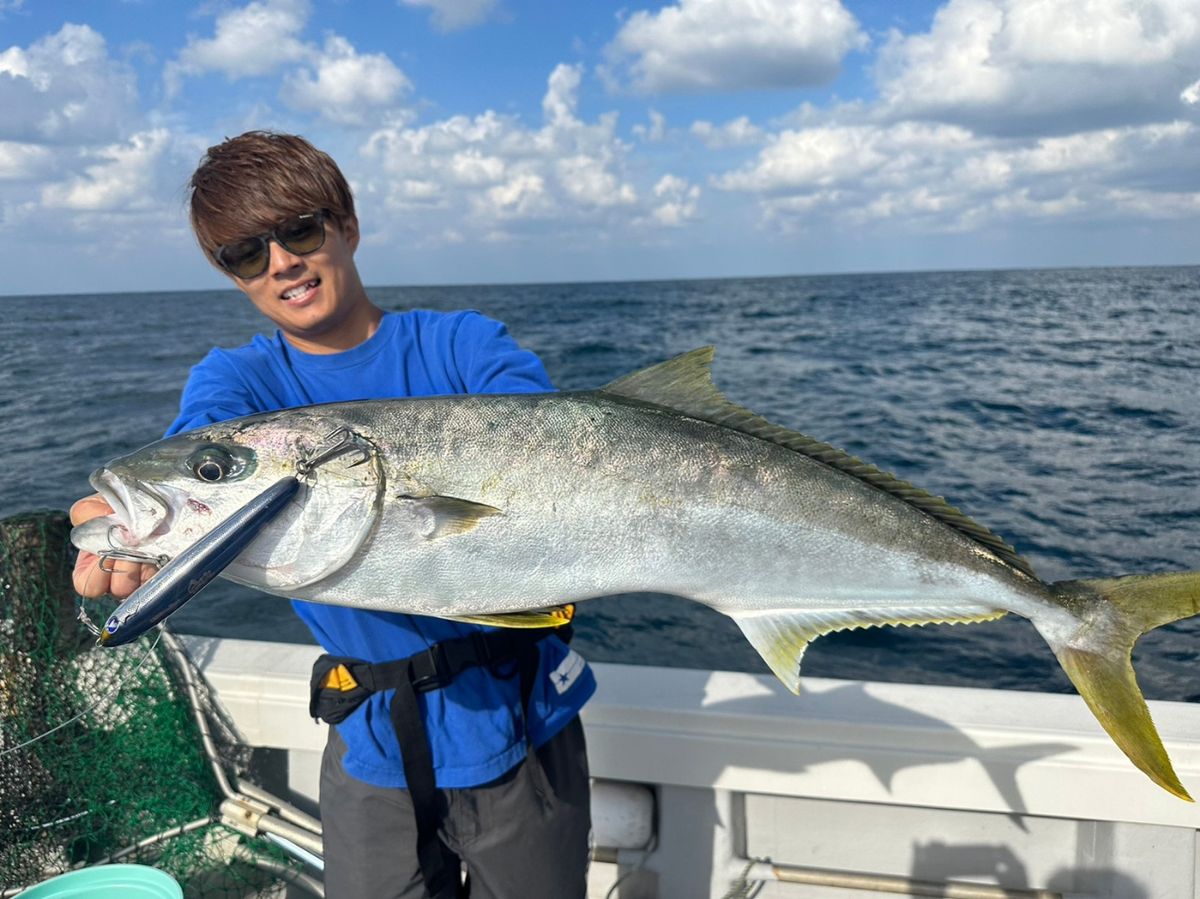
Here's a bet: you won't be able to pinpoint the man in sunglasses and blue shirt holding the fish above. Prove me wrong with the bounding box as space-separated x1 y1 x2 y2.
71 132 595 899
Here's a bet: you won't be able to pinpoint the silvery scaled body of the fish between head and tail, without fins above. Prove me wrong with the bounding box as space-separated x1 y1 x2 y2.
301 394 1022 617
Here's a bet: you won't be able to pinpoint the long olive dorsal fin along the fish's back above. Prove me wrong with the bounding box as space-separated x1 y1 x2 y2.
601 347 1037 577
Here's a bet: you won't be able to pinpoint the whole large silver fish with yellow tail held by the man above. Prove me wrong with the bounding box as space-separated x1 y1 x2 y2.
73 348 1200 798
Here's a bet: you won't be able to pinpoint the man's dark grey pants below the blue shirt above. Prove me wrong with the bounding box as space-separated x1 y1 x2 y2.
320 718 592 899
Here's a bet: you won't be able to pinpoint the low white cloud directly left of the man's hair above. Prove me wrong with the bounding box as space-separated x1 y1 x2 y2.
42 128 170 212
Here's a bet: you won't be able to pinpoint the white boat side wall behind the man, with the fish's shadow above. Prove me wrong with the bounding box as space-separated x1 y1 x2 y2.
182 636 1200 899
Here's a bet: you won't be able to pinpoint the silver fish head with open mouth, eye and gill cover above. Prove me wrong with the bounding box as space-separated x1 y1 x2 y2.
71 407 384 595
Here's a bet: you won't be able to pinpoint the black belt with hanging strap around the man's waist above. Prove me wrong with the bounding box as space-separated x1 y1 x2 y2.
308 624 571 899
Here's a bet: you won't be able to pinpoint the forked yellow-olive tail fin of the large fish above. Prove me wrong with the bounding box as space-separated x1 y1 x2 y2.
1043 571 1200 802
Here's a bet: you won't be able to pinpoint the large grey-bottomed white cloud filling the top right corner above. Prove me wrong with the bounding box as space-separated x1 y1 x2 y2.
876 0 1200 134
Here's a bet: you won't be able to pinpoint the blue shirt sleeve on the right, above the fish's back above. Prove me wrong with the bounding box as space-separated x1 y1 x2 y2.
450 312 554 394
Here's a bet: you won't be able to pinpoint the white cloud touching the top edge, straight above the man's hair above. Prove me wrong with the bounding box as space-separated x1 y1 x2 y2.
164 0 316 92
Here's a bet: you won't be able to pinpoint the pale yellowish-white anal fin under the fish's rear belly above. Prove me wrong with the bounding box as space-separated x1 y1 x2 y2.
730 609 1006 693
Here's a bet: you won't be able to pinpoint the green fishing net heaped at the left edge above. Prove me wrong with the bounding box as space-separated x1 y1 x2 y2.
0 513 316 897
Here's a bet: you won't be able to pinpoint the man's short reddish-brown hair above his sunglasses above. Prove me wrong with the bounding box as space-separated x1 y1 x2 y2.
188 131 354 259
